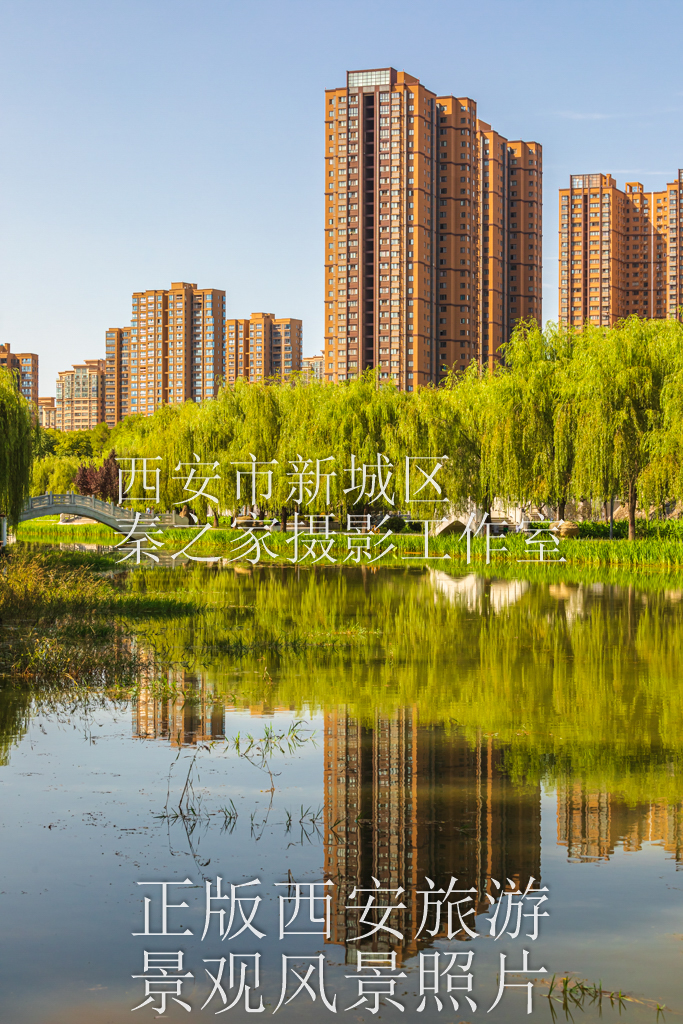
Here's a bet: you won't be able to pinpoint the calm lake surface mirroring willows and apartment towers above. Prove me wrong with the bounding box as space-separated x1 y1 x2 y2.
0 567 683 1024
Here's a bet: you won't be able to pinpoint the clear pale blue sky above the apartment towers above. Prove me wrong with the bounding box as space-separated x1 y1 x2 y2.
0 0 683 395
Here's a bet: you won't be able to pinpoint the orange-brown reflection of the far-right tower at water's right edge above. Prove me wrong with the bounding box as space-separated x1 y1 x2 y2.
557 782 683 870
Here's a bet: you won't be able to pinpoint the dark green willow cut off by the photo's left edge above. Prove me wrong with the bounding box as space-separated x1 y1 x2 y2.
0 369 34 525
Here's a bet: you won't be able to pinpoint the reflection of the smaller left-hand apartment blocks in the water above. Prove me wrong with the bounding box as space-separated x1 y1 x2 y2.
133 672 294 746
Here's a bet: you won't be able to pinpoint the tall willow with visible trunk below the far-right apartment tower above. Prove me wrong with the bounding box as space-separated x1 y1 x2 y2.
568 316 670 540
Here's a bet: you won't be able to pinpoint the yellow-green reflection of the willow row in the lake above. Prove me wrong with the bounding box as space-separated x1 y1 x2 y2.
122 568 683 803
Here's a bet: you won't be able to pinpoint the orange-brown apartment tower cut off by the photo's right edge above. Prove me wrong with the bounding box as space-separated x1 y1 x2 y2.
558 170 683 327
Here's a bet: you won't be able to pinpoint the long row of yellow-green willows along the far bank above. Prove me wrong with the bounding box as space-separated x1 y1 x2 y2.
15 316 683 539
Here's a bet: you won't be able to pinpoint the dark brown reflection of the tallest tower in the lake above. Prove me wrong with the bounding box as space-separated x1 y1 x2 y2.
325 708 541 959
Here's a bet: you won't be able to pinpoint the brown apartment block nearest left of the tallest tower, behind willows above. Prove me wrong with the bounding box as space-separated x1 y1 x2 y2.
225 313 303 384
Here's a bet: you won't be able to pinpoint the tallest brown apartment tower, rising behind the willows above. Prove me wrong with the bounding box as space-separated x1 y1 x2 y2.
325 68 543 390
